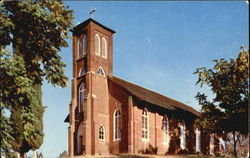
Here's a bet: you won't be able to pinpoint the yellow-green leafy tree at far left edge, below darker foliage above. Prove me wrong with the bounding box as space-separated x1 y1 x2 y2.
0 50 37 156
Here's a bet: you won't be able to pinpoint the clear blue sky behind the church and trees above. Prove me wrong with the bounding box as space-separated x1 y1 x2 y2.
38 1 249 158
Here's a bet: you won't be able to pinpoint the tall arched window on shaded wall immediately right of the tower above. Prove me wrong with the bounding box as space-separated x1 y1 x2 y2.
114 109 122 140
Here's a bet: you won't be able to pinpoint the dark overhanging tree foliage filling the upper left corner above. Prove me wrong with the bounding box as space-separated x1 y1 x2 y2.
0 0 73 87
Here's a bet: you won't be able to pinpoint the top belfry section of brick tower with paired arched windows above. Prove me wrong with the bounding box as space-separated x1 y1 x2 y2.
72 18 115 77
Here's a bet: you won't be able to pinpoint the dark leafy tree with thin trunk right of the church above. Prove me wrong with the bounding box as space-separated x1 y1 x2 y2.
194 47 249 157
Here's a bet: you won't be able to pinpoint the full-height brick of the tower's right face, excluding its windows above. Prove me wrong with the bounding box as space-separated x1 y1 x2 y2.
87 22 112 155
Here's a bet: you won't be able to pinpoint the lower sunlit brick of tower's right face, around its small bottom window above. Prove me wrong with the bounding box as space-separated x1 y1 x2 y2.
90 73 110 155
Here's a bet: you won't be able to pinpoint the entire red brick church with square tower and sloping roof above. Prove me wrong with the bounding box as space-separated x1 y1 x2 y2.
65 18 217 157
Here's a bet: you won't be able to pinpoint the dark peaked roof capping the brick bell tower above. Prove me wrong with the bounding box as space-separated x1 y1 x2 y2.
70 18 115 33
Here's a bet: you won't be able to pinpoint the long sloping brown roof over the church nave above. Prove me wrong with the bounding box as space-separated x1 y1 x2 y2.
108 76 200 117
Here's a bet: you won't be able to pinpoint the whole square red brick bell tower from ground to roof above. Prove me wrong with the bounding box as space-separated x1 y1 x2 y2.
68 18 115 156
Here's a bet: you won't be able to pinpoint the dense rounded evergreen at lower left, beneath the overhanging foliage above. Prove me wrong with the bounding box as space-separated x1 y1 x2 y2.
10 85 44 155
